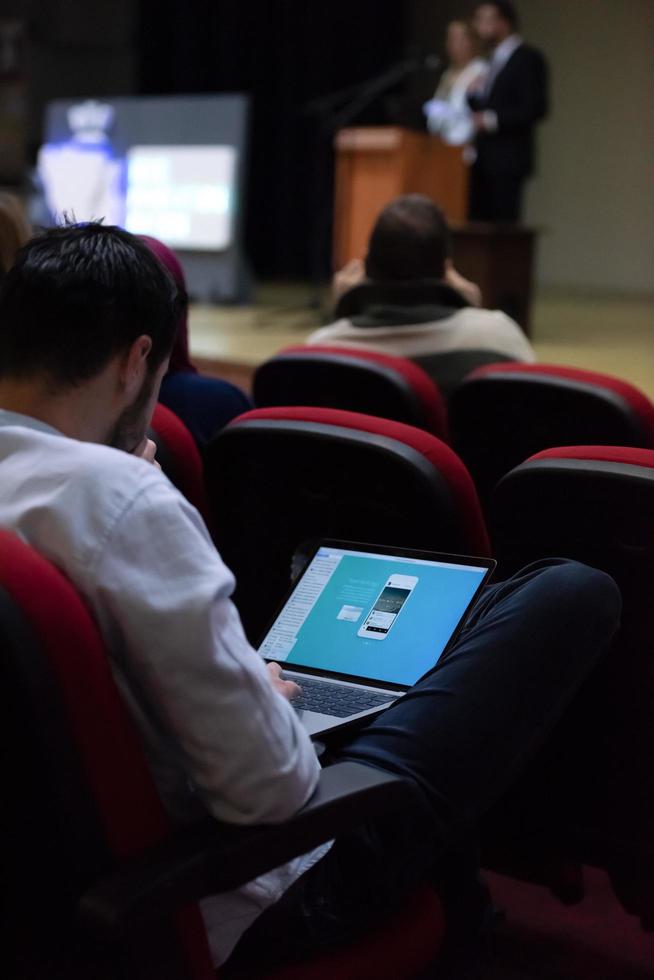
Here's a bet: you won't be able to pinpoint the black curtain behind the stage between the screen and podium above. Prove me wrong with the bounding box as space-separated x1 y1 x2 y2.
137 0 406 275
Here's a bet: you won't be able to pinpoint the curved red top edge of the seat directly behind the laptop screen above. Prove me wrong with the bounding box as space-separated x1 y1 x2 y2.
230 406 490 557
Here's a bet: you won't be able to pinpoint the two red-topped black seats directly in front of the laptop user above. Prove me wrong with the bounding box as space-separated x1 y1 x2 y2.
149 390 654 928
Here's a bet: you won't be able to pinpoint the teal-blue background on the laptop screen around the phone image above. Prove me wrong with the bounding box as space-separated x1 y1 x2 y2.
284 555 485 685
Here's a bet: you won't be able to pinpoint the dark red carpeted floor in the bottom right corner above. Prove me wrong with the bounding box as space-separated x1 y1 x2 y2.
461 869 654 980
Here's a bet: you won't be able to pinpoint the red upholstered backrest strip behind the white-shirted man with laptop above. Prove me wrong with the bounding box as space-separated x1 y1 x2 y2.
0 530 214 980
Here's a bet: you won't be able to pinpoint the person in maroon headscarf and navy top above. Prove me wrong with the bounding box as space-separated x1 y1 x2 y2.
141 235 253 448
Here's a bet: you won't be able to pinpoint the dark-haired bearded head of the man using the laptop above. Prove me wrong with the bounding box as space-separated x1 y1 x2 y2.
0 224 183 457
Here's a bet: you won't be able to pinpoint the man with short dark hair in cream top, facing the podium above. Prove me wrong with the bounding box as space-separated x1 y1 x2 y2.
308 194 535 384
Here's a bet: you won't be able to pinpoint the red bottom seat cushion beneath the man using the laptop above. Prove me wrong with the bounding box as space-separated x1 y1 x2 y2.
266 886 445 980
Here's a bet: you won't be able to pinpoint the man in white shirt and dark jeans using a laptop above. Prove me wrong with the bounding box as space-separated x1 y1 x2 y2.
0 224 620 975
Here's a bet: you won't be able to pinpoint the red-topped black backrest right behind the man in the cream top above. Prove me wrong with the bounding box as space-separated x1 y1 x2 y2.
253 345 447 439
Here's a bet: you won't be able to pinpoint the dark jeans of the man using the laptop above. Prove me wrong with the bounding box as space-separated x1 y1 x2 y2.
228 559 621 976
